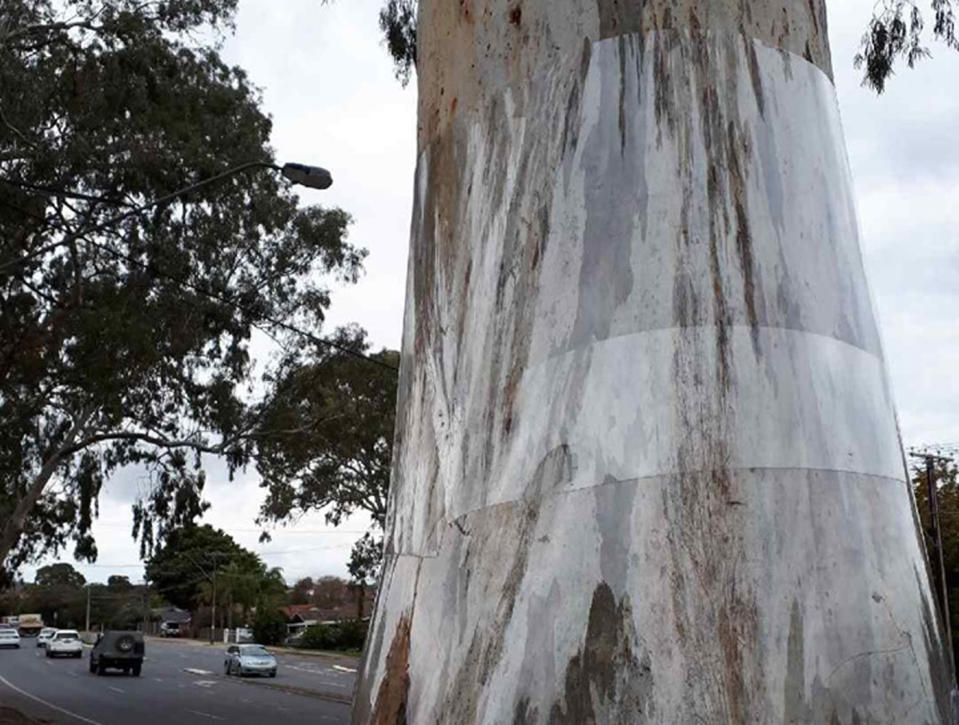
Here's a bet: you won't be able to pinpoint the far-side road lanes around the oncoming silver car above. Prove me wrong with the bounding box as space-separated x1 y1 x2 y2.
144 639 356 699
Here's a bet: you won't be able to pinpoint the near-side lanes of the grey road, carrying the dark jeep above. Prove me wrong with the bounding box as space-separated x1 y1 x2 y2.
0 647 349 725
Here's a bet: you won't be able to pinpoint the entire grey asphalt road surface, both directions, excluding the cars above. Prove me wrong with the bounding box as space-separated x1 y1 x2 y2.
0 639 356 725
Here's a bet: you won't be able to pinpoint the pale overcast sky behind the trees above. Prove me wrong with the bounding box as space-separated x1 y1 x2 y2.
24 0 959 581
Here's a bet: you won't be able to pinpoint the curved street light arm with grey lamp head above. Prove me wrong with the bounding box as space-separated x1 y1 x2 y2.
0 161 333 272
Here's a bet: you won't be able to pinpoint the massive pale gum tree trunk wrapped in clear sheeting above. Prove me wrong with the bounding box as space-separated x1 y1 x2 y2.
353 0 951 725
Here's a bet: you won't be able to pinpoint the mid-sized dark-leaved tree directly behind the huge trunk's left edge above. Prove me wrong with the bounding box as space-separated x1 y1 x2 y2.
255 327 399 582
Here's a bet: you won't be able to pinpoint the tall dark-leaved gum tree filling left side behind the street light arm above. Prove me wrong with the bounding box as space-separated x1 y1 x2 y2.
0 0 365 569
